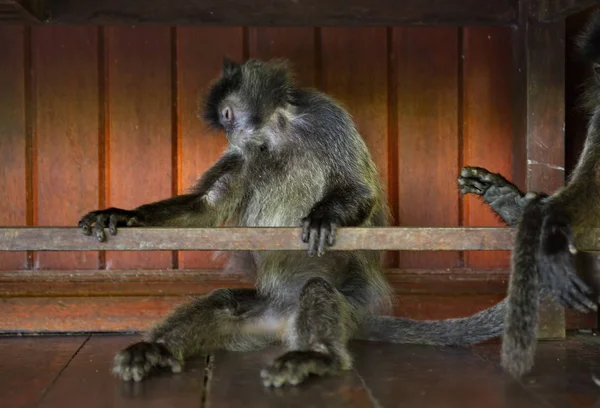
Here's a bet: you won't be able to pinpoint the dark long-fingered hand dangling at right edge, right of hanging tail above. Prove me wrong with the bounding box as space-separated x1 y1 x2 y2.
539 212 598 313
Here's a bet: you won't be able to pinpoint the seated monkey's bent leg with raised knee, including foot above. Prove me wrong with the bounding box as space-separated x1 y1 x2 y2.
261 278 354 387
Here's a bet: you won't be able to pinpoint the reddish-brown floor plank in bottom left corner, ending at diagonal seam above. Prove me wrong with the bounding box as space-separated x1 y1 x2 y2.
0 336 87 408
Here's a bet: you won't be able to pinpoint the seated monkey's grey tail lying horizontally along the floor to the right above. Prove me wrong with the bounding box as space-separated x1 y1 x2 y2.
355 298 507 346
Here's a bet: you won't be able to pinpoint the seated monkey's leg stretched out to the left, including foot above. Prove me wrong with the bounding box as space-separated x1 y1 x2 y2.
113 289 276 381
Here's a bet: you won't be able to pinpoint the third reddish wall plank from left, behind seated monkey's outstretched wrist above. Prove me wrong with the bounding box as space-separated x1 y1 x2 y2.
106 27 174 269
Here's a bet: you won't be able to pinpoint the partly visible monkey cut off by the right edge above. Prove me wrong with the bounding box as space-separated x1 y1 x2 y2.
458 12 600 377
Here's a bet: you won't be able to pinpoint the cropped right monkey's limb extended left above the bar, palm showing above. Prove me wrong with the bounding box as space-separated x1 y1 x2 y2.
458 167 535 227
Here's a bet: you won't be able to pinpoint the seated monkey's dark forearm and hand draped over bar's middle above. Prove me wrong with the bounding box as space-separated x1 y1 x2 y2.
302 185 375 256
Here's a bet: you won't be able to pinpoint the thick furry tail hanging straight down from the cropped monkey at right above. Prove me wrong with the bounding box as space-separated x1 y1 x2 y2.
501 194 546 377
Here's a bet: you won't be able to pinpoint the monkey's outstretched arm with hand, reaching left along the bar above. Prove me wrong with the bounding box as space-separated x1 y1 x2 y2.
78 153 241 241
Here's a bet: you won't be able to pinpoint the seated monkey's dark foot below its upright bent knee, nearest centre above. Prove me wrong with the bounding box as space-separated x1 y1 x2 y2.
260 351 341 387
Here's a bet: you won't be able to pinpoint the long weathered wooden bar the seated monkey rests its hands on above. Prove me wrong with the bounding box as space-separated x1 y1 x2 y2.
0 227 515 251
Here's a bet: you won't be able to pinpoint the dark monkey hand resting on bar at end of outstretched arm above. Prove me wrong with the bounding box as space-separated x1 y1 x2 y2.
77 207 143 242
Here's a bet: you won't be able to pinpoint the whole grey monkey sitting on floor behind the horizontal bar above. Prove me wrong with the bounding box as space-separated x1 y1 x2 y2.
78 59 505 387
